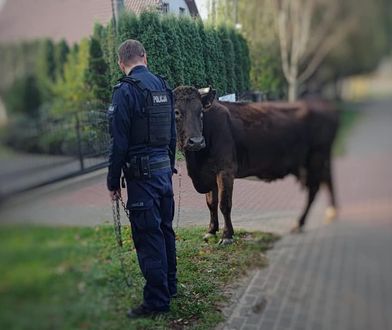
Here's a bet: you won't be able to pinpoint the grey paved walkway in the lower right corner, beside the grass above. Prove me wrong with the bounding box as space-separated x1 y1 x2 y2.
222 221 392 330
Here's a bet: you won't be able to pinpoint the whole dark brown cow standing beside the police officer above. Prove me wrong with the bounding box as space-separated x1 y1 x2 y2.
174 86 338 244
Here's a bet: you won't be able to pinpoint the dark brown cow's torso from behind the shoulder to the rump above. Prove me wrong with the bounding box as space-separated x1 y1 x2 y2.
222 101 336 180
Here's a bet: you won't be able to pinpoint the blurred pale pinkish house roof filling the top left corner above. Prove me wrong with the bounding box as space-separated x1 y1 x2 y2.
0 0 112 43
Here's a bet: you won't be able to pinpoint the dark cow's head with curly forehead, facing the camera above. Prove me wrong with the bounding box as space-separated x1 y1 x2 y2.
173 86 216 152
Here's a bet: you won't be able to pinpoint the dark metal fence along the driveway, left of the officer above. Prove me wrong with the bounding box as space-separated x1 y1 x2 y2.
0 111 109 199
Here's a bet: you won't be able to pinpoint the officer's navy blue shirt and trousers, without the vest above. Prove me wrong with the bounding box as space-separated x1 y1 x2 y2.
107 66 177 311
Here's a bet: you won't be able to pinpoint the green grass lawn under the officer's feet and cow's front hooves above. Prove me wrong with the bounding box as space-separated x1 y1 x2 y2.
0 226 277 330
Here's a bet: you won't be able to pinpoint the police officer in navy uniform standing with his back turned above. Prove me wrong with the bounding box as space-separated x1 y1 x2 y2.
107 40 177 318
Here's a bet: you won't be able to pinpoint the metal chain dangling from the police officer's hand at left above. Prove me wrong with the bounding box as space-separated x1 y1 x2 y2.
112 197 132 288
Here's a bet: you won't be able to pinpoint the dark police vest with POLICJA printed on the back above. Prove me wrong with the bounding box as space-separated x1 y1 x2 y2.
120 76 172 147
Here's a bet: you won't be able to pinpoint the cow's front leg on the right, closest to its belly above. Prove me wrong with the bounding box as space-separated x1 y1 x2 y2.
217 172 234 244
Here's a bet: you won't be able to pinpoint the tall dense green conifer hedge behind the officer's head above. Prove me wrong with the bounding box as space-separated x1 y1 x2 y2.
95 12 250 95
